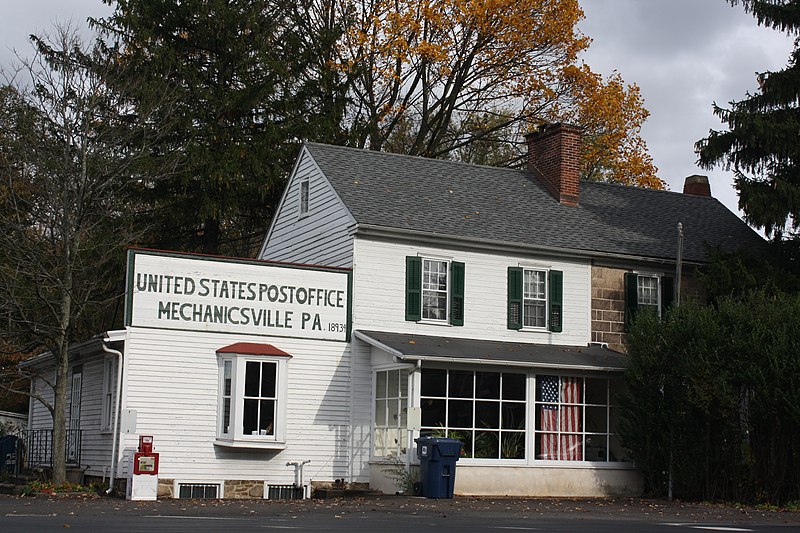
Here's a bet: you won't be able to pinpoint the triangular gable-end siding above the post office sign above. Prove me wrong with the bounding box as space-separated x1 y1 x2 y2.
259 150 355 267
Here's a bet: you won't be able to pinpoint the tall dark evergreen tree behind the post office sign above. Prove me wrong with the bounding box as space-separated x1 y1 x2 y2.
94 0 341 256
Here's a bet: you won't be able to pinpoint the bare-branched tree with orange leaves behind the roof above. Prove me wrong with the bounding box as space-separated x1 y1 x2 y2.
338 0 664 188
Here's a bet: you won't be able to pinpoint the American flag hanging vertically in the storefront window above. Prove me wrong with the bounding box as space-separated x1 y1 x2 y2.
539 376 583 461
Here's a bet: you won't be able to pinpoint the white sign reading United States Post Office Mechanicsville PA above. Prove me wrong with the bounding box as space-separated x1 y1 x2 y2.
126 250 350 340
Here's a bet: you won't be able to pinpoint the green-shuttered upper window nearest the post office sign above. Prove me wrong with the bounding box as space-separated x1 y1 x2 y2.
406 256 464 326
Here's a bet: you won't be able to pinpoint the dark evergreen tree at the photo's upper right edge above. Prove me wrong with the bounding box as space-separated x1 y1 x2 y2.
696 0 800 239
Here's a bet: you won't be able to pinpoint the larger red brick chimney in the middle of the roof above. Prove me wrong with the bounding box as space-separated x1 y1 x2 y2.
525 123 582 206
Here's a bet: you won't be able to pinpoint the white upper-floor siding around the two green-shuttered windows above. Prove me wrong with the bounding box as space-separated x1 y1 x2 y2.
353 237 591 346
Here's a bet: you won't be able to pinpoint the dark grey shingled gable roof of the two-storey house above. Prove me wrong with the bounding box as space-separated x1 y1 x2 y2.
305 143 764 262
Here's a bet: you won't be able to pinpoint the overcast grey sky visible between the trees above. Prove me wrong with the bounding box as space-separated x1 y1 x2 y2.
0 0 793 227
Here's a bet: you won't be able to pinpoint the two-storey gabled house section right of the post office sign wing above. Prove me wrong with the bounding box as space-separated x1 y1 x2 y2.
260 125 763 496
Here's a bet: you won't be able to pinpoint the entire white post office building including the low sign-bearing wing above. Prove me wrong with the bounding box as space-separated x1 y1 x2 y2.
27 125 761 498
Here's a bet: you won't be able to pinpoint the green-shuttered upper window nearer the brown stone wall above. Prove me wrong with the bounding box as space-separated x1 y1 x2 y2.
508 267 563 332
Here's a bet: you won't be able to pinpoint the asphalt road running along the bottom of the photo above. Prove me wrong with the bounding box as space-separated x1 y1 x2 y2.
0 495 800 533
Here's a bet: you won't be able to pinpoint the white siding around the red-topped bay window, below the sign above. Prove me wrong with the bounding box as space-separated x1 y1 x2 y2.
116 328 356 484
